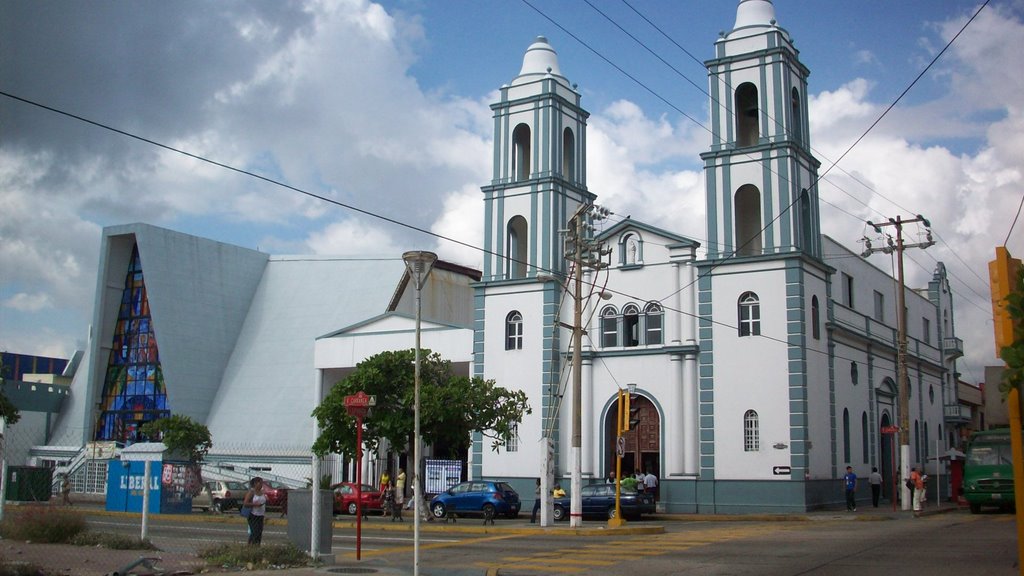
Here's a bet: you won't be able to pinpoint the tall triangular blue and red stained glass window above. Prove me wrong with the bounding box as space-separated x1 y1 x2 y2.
95 245 171 444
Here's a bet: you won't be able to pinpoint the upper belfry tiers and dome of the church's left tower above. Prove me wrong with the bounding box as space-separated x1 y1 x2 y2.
481 36 594 282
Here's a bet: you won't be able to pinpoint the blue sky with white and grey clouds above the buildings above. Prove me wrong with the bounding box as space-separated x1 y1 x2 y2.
0 0 1024 382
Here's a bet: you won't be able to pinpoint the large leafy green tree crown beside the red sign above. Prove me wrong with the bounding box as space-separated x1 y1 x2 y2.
312 349 531 457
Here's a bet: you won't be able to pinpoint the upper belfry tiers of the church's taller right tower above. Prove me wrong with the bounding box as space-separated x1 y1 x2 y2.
700 0 821 259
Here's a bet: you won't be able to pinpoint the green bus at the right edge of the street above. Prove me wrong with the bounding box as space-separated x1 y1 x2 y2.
964 428 1014 513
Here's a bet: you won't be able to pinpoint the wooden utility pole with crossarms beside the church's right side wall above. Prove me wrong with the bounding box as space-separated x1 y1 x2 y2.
860 214 935 510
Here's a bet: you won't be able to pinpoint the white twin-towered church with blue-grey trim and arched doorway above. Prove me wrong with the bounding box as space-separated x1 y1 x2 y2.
473 0 963 512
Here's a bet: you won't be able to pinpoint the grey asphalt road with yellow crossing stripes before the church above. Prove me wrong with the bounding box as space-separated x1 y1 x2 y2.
77 504 1019 576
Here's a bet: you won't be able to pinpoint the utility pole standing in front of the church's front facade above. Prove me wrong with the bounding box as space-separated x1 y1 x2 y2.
565 204 611 528
